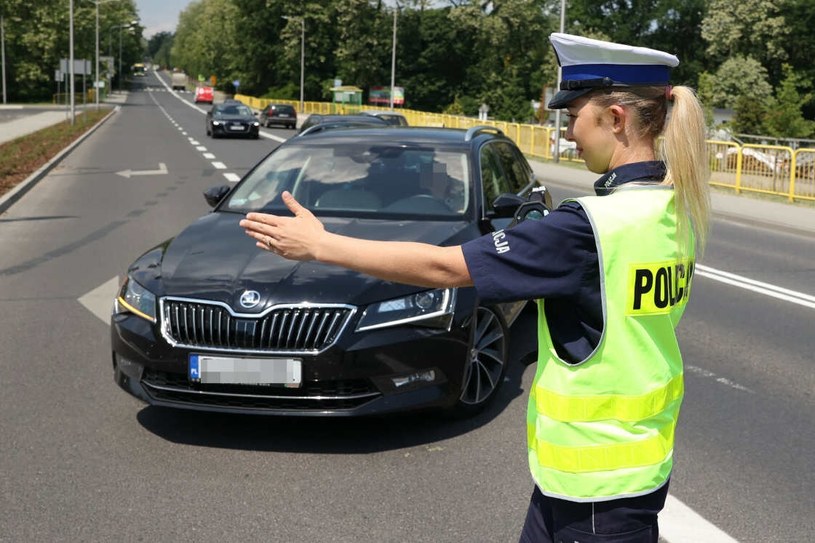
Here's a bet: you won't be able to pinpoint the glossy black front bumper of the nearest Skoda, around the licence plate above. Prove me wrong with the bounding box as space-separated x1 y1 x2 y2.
111 308 470 416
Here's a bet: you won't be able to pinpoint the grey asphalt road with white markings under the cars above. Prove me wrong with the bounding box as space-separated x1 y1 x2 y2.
0 70 815 543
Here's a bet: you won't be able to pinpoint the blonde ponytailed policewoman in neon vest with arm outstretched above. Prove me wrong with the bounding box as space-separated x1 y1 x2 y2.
241 33 709 543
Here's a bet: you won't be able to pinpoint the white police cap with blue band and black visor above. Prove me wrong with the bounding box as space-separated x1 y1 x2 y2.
549 32 679 109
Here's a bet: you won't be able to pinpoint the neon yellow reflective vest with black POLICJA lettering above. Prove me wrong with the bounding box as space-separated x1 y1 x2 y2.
527 186 694 502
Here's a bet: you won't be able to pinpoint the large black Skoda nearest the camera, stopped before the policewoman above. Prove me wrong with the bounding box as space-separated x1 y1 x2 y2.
110 126 536 417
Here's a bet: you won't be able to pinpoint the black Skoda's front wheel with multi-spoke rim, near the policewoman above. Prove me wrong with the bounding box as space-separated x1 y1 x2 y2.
447 306 509 418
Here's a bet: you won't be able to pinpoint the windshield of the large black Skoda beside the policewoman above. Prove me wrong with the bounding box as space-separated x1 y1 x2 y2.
226 142 472 220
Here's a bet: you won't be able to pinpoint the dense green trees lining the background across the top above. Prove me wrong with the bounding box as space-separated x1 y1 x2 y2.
0 0 815 134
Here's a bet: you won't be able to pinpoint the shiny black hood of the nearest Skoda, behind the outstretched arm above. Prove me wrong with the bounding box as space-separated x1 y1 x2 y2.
129 212 470 313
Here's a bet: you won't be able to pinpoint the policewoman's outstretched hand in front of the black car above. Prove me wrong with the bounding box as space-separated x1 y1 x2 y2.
240 191 326 260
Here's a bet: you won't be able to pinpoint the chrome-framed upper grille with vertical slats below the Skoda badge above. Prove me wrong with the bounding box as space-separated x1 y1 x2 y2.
161 298 354 354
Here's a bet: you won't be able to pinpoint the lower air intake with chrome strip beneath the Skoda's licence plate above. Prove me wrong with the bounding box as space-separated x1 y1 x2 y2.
142 368 382 411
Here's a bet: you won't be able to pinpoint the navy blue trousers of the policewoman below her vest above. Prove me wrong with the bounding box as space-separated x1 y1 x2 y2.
520 483 668 543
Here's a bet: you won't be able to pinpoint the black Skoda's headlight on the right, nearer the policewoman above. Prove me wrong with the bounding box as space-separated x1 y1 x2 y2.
357 288 456 332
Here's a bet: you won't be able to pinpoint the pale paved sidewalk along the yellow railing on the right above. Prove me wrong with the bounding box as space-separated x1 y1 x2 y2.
529 160 815 236
